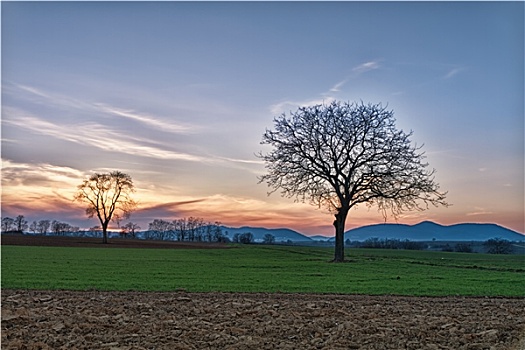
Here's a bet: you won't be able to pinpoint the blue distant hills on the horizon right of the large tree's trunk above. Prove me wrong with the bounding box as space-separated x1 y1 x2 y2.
330 221 525 242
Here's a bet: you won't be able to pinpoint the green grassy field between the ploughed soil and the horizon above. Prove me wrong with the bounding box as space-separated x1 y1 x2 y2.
2 245 525 297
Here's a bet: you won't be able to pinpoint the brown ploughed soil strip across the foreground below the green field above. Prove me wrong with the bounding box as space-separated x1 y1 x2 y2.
1 236 525 350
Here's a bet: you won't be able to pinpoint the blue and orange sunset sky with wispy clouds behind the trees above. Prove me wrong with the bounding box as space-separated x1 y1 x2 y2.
1 1 525 236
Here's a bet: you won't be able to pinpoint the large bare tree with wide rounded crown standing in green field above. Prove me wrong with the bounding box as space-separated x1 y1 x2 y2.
258 101 448 262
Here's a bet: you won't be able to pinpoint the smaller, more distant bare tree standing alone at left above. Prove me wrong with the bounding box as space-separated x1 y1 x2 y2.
75 171 136 243
